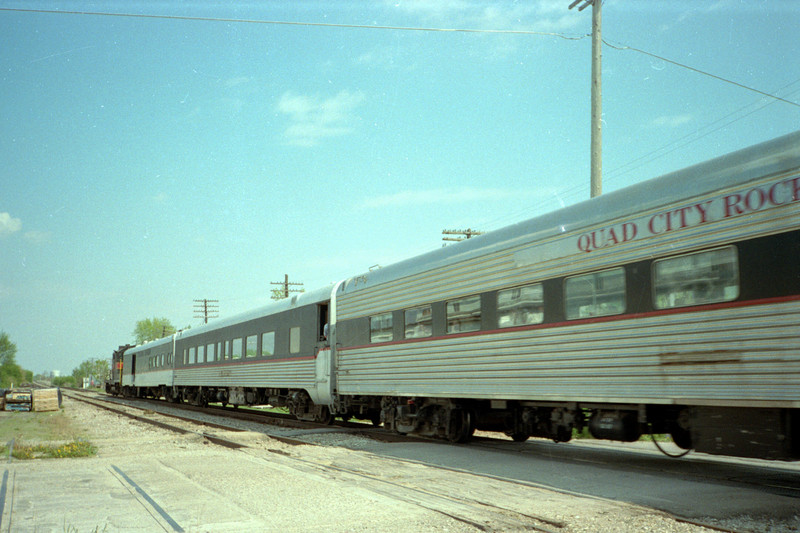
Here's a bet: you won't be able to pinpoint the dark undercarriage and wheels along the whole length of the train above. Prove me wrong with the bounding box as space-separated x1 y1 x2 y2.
110 386 800 461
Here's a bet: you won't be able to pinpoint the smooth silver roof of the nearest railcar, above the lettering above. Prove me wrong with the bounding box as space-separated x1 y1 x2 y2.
339 131 800 294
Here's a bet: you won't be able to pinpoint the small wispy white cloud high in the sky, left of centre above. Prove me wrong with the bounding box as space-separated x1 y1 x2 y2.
277 91 365 146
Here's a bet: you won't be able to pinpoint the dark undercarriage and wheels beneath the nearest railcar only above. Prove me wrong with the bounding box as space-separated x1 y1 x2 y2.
372 397 800 461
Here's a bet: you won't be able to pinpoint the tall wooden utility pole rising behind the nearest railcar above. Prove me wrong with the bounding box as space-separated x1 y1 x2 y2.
569 0 603 198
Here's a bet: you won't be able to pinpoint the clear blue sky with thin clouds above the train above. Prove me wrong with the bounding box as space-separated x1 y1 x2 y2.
0 0 800 373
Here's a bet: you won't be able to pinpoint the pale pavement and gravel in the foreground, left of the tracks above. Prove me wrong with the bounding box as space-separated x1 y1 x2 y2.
0 440 466 533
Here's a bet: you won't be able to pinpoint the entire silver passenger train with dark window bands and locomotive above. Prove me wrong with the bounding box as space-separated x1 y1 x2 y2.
107 132 800 460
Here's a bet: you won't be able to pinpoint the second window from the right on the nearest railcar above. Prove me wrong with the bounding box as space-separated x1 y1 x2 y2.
565 267 625 320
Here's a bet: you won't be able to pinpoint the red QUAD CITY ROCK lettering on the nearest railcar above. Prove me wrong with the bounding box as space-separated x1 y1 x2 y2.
576 172 800 252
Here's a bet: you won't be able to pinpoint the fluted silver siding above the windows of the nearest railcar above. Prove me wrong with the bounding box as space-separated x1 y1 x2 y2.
337 176 800 320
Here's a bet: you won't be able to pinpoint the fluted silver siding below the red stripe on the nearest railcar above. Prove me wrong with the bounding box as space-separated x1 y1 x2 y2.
338 301 800 407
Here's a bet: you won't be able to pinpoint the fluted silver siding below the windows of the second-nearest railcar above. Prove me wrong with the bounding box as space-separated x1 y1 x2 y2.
175 359 315 389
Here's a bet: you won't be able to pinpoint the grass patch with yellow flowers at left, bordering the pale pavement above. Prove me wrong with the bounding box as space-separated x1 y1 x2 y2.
0 410 97 460
